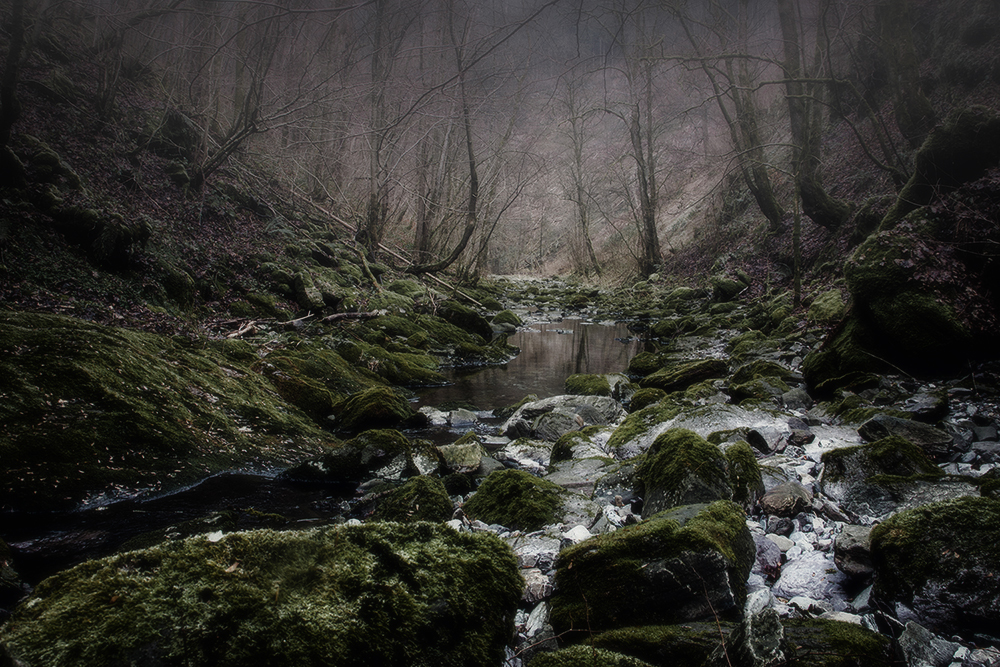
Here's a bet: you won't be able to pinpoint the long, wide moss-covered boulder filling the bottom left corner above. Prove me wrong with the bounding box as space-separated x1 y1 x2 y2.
0 522 523 667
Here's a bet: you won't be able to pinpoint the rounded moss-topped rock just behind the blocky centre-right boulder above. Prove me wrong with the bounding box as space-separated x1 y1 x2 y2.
637 429 733 518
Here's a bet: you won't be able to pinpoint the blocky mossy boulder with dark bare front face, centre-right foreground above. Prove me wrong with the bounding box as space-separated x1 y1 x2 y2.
551 500 756 641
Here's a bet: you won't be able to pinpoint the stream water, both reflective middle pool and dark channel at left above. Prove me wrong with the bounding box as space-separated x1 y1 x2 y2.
2 318 642 585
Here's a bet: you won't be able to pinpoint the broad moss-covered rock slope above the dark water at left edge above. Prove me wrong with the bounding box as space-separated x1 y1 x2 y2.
0 313 331 510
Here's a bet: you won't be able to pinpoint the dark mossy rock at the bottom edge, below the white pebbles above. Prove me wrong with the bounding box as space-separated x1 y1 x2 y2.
782 619 897 667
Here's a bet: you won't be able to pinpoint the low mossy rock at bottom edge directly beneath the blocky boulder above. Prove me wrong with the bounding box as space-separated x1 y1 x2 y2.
594 621 732 665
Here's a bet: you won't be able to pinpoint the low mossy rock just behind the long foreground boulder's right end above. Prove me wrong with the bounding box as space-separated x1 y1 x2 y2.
465 470 567 531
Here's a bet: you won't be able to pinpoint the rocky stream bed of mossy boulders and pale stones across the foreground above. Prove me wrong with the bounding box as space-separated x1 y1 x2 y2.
0 282 1000 667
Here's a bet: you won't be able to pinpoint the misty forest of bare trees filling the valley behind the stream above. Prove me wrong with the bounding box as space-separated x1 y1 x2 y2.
0 0 1000 282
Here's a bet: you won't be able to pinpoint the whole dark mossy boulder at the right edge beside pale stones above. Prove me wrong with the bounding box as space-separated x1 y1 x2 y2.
871 497 1000 638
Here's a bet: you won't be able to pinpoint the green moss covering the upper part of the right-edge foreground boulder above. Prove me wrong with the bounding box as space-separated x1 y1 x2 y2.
871 497 1000 614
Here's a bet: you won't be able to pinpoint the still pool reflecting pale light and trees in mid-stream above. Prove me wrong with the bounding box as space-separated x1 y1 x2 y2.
419 319 642 410
